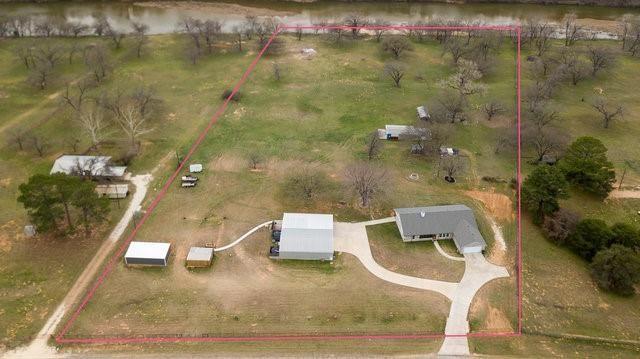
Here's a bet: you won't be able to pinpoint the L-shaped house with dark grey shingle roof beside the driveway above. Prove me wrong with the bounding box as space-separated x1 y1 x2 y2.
394 204 487 254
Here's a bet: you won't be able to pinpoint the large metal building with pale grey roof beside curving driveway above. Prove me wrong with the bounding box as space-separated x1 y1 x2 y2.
271 213 333 260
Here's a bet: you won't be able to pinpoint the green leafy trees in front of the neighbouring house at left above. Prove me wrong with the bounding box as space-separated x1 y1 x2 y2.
18 173 109 234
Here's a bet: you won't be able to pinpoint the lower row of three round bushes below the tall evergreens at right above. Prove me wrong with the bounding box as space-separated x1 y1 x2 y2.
543 209 640 295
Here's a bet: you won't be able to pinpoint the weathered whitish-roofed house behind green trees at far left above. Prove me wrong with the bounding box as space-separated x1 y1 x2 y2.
50 155 127 180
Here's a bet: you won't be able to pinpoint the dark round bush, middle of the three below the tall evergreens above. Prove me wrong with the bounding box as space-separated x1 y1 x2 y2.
567 219 613 261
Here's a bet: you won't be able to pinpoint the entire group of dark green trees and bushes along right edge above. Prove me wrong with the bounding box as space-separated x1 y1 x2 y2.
522 137 640 295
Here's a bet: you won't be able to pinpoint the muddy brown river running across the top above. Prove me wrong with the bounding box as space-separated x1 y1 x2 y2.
0 0 640 34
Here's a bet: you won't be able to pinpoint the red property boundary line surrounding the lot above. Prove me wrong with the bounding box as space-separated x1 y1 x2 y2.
54 25 522 344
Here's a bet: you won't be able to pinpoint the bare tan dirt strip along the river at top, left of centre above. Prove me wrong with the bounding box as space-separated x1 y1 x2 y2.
134 1 295 16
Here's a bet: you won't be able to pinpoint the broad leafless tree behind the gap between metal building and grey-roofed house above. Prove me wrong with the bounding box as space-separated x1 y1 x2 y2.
346 162 389 207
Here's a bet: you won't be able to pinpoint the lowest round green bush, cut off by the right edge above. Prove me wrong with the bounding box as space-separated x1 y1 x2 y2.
591 244 640 295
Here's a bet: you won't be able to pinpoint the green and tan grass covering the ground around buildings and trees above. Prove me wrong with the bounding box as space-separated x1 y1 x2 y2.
0 27 640 356
